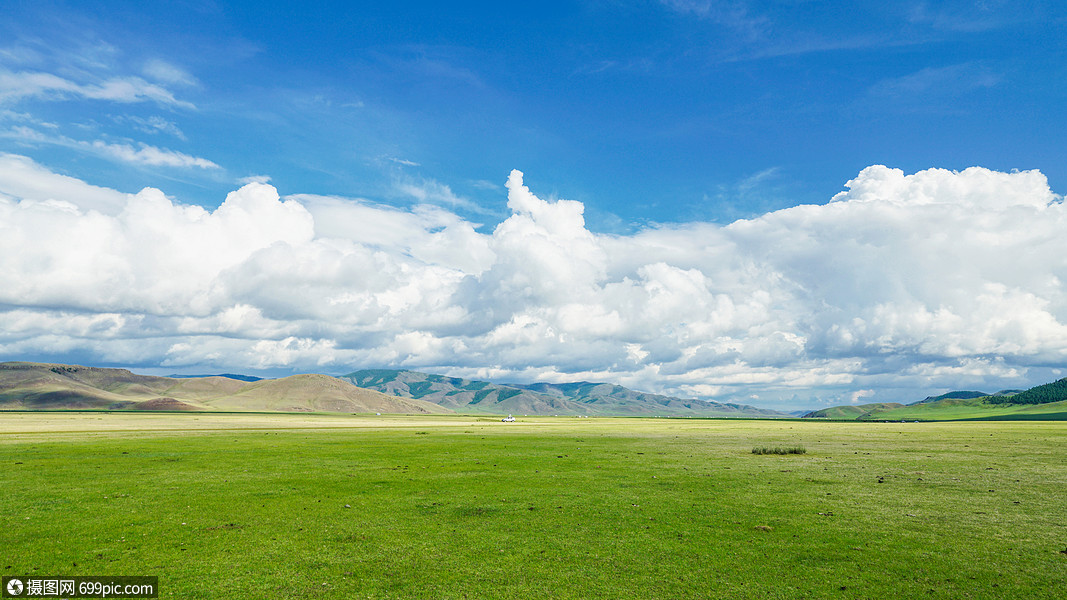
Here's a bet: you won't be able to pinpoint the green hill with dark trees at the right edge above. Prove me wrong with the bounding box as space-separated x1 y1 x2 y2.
803 378 1067 421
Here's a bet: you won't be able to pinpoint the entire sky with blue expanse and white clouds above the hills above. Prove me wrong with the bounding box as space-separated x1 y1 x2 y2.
0 0 1067 409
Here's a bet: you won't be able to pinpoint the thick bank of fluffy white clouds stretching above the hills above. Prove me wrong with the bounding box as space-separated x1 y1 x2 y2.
0 155 1067 406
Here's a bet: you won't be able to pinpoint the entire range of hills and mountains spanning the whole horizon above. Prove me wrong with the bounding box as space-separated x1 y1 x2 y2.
16 362 1067 421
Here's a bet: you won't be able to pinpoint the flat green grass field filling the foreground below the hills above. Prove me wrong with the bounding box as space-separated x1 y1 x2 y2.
0 413 1067 599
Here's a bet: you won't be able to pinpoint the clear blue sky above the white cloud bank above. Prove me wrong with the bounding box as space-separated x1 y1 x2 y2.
0 1 1067 224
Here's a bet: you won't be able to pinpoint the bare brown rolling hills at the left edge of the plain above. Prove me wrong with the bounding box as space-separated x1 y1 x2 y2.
0 362 449 413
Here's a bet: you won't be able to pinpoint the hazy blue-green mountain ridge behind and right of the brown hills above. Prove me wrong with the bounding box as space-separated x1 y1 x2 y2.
341 369 791 417
